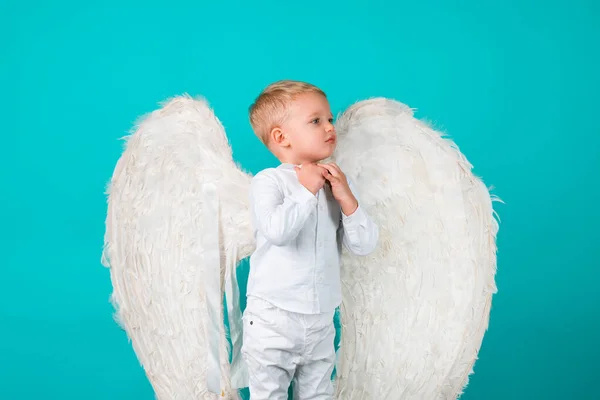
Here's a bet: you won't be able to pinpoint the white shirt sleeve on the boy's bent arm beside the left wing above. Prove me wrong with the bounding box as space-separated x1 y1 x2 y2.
250 172 317 246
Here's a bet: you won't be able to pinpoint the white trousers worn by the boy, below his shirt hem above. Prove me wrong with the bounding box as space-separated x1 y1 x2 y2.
242 297 335 400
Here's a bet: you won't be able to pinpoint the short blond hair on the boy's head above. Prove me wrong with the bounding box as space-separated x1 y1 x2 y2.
249 80 327 145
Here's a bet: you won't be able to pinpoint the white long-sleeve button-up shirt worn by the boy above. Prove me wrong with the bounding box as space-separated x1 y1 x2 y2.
247 164 379 314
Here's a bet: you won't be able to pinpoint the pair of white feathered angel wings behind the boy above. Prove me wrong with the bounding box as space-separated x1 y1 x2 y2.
103 96 498 400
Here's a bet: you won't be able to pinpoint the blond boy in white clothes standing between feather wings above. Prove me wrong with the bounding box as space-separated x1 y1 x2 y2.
242 81 379 400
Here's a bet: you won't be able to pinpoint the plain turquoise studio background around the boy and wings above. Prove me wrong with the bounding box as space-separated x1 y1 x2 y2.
0 0 600 400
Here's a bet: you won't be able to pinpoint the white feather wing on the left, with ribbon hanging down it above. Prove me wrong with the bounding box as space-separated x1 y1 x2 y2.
104 96 254 399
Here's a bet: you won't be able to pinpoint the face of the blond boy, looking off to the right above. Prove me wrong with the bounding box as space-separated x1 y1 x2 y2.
281 93 337 164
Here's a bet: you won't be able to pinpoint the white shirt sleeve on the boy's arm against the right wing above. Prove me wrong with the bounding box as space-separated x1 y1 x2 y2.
342 182 379 256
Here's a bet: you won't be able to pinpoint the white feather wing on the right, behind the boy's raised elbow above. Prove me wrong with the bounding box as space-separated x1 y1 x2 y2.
335 99 498 400
